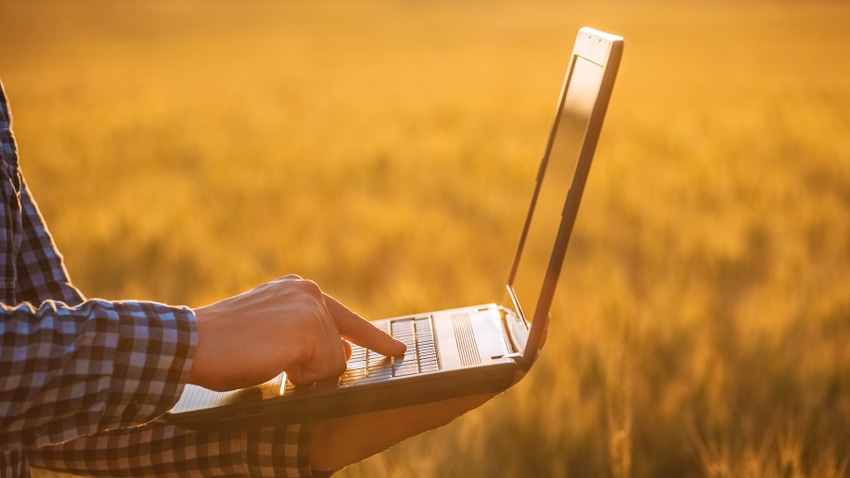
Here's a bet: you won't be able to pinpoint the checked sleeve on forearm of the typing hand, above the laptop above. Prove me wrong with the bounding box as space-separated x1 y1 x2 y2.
0 300 197 449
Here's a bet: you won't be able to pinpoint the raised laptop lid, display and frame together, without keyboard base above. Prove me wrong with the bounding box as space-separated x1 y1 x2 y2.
507 28 623 369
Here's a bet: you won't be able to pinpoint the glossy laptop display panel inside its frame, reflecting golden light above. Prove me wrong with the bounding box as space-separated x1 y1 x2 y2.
508 36 616 340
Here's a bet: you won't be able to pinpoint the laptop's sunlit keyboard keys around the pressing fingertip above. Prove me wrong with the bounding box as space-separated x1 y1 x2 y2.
339 316 440 386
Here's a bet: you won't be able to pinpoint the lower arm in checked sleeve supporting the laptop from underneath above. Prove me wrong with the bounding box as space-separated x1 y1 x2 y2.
28 396 491 478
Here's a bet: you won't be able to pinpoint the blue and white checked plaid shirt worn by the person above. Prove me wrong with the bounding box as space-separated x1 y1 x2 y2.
0 84 310 478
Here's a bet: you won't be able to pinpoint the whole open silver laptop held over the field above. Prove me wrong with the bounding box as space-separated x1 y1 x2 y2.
165 28 623 431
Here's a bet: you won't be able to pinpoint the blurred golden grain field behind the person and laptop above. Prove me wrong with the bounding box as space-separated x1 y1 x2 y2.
0 0 850 478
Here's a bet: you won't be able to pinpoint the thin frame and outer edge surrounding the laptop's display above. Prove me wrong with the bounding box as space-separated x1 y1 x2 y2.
507 27 623 370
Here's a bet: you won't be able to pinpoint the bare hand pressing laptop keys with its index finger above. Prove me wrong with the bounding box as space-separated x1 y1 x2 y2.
189 276 406 391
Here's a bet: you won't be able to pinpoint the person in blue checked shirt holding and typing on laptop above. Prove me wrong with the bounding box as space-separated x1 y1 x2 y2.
0 80 504 476
